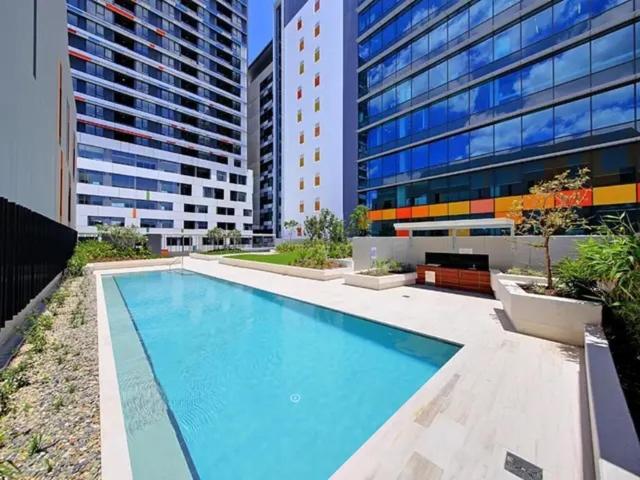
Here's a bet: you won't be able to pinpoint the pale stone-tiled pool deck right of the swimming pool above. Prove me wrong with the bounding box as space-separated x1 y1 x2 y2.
184 258 594 480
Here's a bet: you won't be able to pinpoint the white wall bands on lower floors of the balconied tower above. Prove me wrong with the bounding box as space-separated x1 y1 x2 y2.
77 133 253 245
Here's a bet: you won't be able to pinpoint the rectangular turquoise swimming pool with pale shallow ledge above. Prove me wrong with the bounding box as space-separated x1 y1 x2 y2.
102 270 459 479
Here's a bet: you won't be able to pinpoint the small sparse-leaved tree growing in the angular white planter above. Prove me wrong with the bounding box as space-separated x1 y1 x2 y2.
510 168 589 290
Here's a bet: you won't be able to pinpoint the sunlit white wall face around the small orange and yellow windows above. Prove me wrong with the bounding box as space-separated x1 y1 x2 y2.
282 0 344 234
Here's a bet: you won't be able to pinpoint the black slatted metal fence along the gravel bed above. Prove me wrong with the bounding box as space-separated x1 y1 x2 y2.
0 197 76 328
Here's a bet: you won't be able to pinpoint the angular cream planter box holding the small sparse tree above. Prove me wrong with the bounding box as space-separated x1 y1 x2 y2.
492 275 602 346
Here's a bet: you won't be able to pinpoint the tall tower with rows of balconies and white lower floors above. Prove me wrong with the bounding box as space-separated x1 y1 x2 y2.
68 0 253 247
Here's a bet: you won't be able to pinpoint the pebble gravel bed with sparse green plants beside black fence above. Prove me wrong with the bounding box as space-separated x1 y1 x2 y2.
0 275 100 479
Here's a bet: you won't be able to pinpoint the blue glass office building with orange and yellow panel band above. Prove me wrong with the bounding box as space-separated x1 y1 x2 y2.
358 0 640 235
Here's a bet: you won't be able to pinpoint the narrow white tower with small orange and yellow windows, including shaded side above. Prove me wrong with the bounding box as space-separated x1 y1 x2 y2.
274 0 357 236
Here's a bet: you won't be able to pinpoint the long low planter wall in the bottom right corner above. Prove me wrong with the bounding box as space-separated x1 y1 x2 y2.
584 325 640 480
